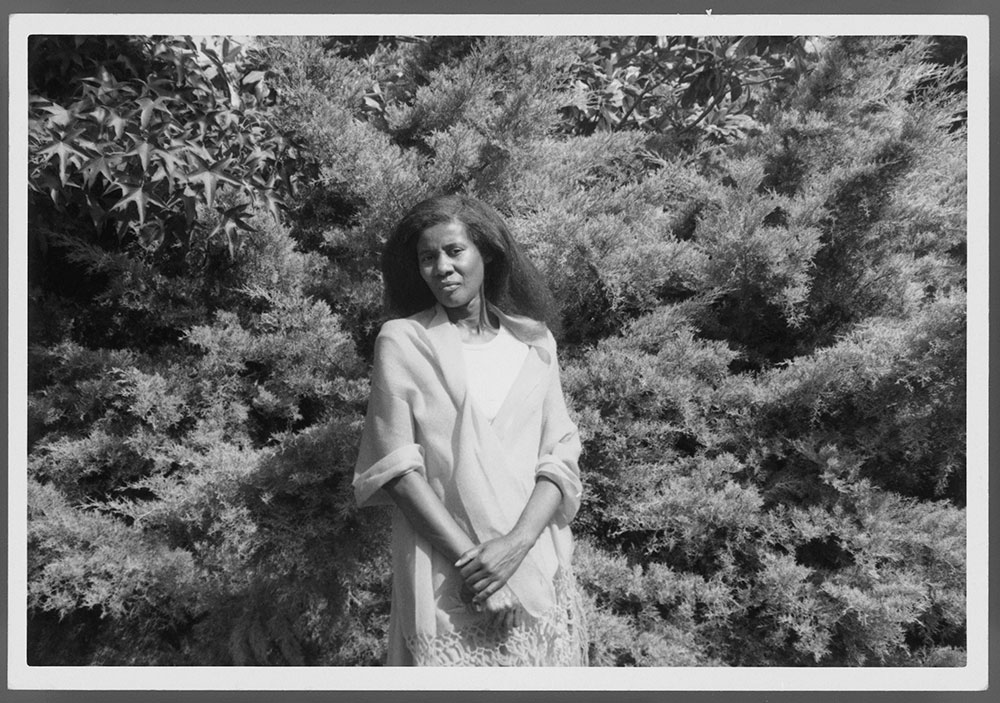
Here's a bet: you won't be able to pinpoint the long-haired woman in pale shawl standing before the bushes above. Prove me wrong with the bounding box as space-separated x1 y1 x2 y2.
354 195 586 666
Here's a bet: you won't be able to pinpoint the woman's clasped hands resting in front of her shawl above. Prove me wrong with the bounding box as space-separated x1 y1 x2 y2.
455 534 530 629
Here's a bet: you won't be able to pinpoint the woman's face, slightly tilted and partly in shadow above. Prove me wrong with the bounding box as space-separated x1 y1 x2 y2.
417 221 486 313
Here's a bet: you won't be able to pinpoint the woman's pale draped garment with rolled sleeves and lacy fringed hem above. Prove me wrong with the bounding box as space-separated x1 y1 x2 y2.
354 305 583 665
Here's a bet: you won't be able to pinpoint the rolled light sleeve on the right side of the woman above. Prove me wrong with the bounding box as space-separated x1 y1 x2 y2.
535 348 583 524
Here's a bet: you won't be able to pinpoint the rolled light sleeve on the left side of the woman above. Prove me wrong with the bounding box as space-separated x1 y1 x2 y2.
353 333 424 507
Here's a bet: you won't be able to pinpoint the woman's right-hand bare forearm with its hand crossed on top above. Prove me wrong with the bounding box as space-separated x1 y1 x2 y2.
455 476 563 603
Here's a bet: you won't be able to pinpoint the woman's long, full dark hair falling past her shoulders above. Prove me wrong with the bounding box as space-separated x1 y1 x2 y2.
382 195 560 334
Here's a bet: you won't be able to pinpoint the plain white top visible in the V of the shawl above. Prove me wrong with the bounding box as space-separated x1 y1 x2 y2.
462 325 529 420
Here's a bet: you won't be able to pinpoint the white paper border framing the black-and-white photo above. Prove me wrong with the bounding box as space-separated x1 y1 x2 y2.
7 14 989 691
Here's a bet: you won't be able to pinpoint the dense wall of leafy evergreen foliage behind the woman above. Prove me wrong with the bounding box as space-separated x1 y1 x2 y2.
28 37 966 666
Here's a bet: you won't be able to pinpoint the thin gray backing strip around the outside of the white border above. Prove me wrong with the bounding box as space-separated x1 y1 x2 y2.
0 0 1000 703
